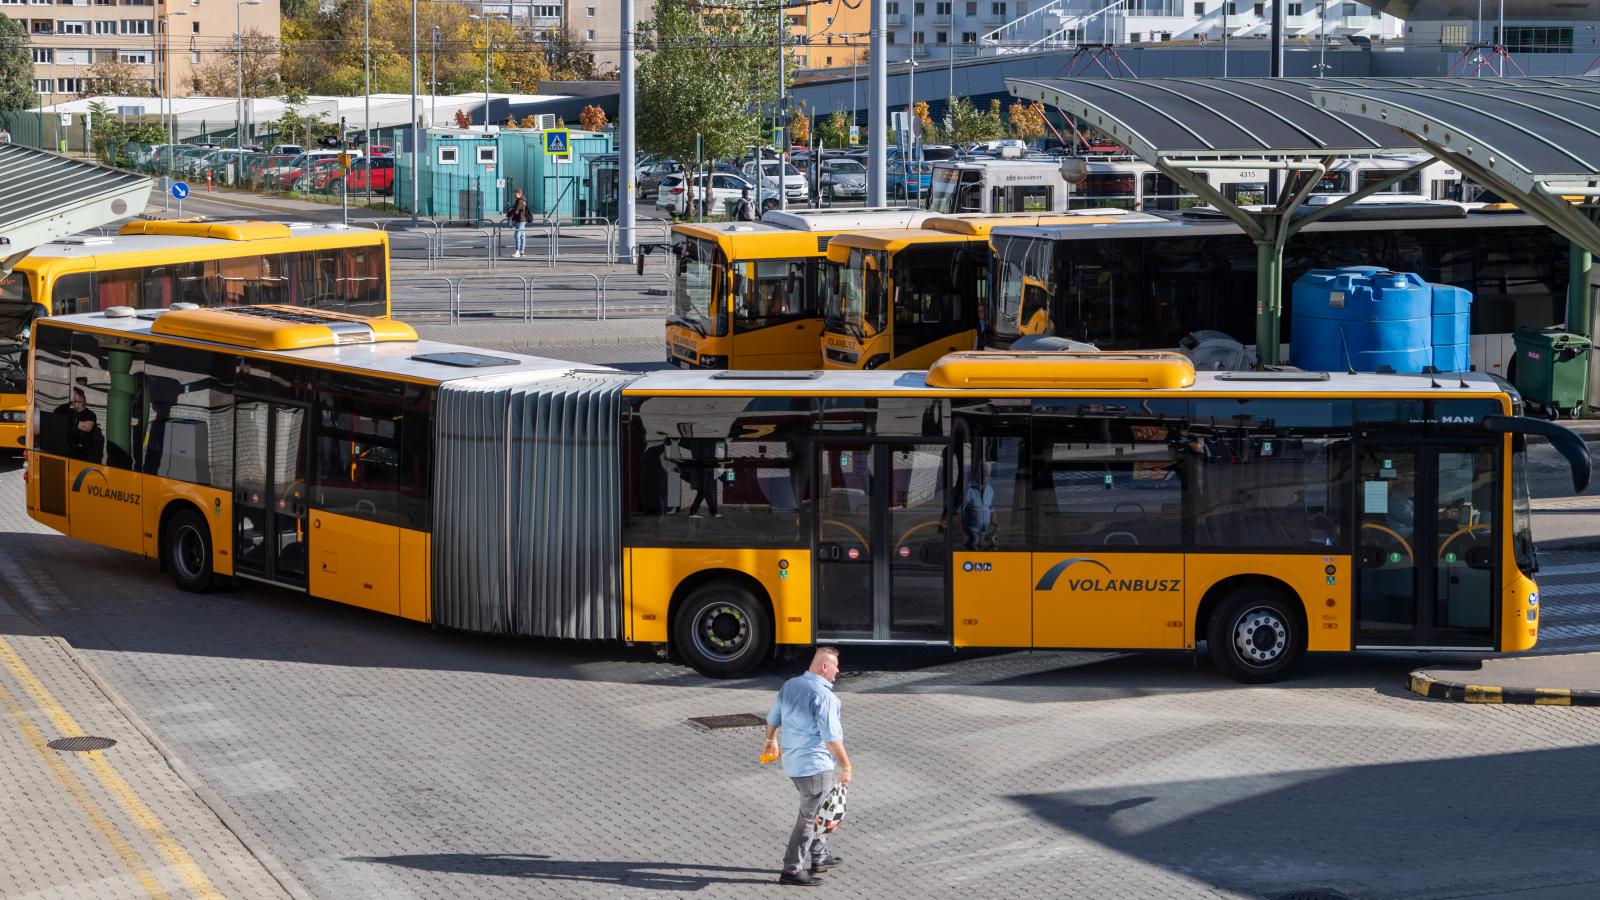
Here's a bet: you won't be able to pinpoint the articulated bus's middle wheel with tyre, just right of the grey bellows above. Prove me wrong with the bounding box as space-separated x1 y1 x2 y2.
672 581 773 677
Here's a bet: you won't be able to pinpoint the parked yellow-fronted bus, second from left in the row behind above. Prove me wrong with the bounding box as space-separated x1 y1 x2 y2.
822 210 1160 368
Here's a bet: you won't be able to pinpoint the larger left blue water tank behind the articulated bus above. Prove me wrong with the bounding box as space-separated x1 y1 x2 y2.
1290 266 1434 372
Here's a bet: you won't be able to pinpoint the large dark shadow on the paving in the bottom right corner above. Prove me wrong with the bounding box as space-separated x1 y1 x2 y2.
1010 746 1600 897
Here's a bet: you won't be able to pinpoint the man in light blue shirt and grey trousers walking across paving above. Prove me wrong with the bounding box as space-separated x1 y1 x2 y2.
765 647 850 887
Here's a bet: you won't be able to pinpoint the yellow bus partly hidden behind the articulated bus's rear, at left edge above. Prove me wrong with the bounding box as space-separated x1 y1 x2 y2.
0 221 389 450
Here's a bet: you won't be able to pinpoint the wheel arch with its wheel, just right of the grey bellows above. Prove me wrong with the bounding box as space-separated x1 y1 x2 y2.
667 569 776 677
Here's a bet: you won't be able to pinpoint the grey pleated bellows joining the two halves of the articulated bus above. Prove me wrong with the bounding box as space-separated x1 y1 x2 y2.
432 372 637 639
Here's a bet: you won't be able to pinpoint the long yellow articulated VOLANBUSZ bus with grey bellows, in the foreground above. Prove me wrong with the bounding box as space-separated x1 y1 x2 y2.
27 307 1589 682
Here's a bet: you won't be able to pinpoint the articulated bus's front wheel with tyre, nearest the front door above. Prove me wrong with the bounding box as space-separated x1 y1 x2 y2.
1206 585 1306 684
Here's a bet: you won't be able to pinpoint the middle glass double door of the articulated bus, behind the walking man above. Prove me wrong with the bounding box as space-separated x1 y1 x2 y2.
814 442 950 644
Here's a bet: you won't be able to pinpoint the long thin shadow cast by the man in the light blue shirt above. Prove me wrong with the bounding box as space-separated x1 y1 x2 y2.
349 854 778 890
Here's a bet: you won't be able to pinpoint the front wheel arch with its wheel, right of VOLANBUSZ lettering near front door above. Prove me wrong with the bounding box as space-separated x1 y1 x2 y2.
1195 575 1309 684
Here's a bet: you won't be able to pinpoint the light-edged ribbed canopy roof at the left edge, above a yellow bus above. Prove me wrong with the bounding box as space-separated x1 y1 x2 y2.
0 144 150 259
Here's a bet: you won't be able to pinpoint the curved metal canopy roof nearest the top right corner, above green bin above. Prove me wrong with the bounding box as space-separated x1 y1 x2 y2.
1312 77 1600 253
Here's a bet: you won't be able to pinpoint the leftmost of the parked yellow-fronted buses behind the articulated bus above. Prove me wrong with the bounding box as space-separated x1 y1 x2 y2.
662 207 930 368
